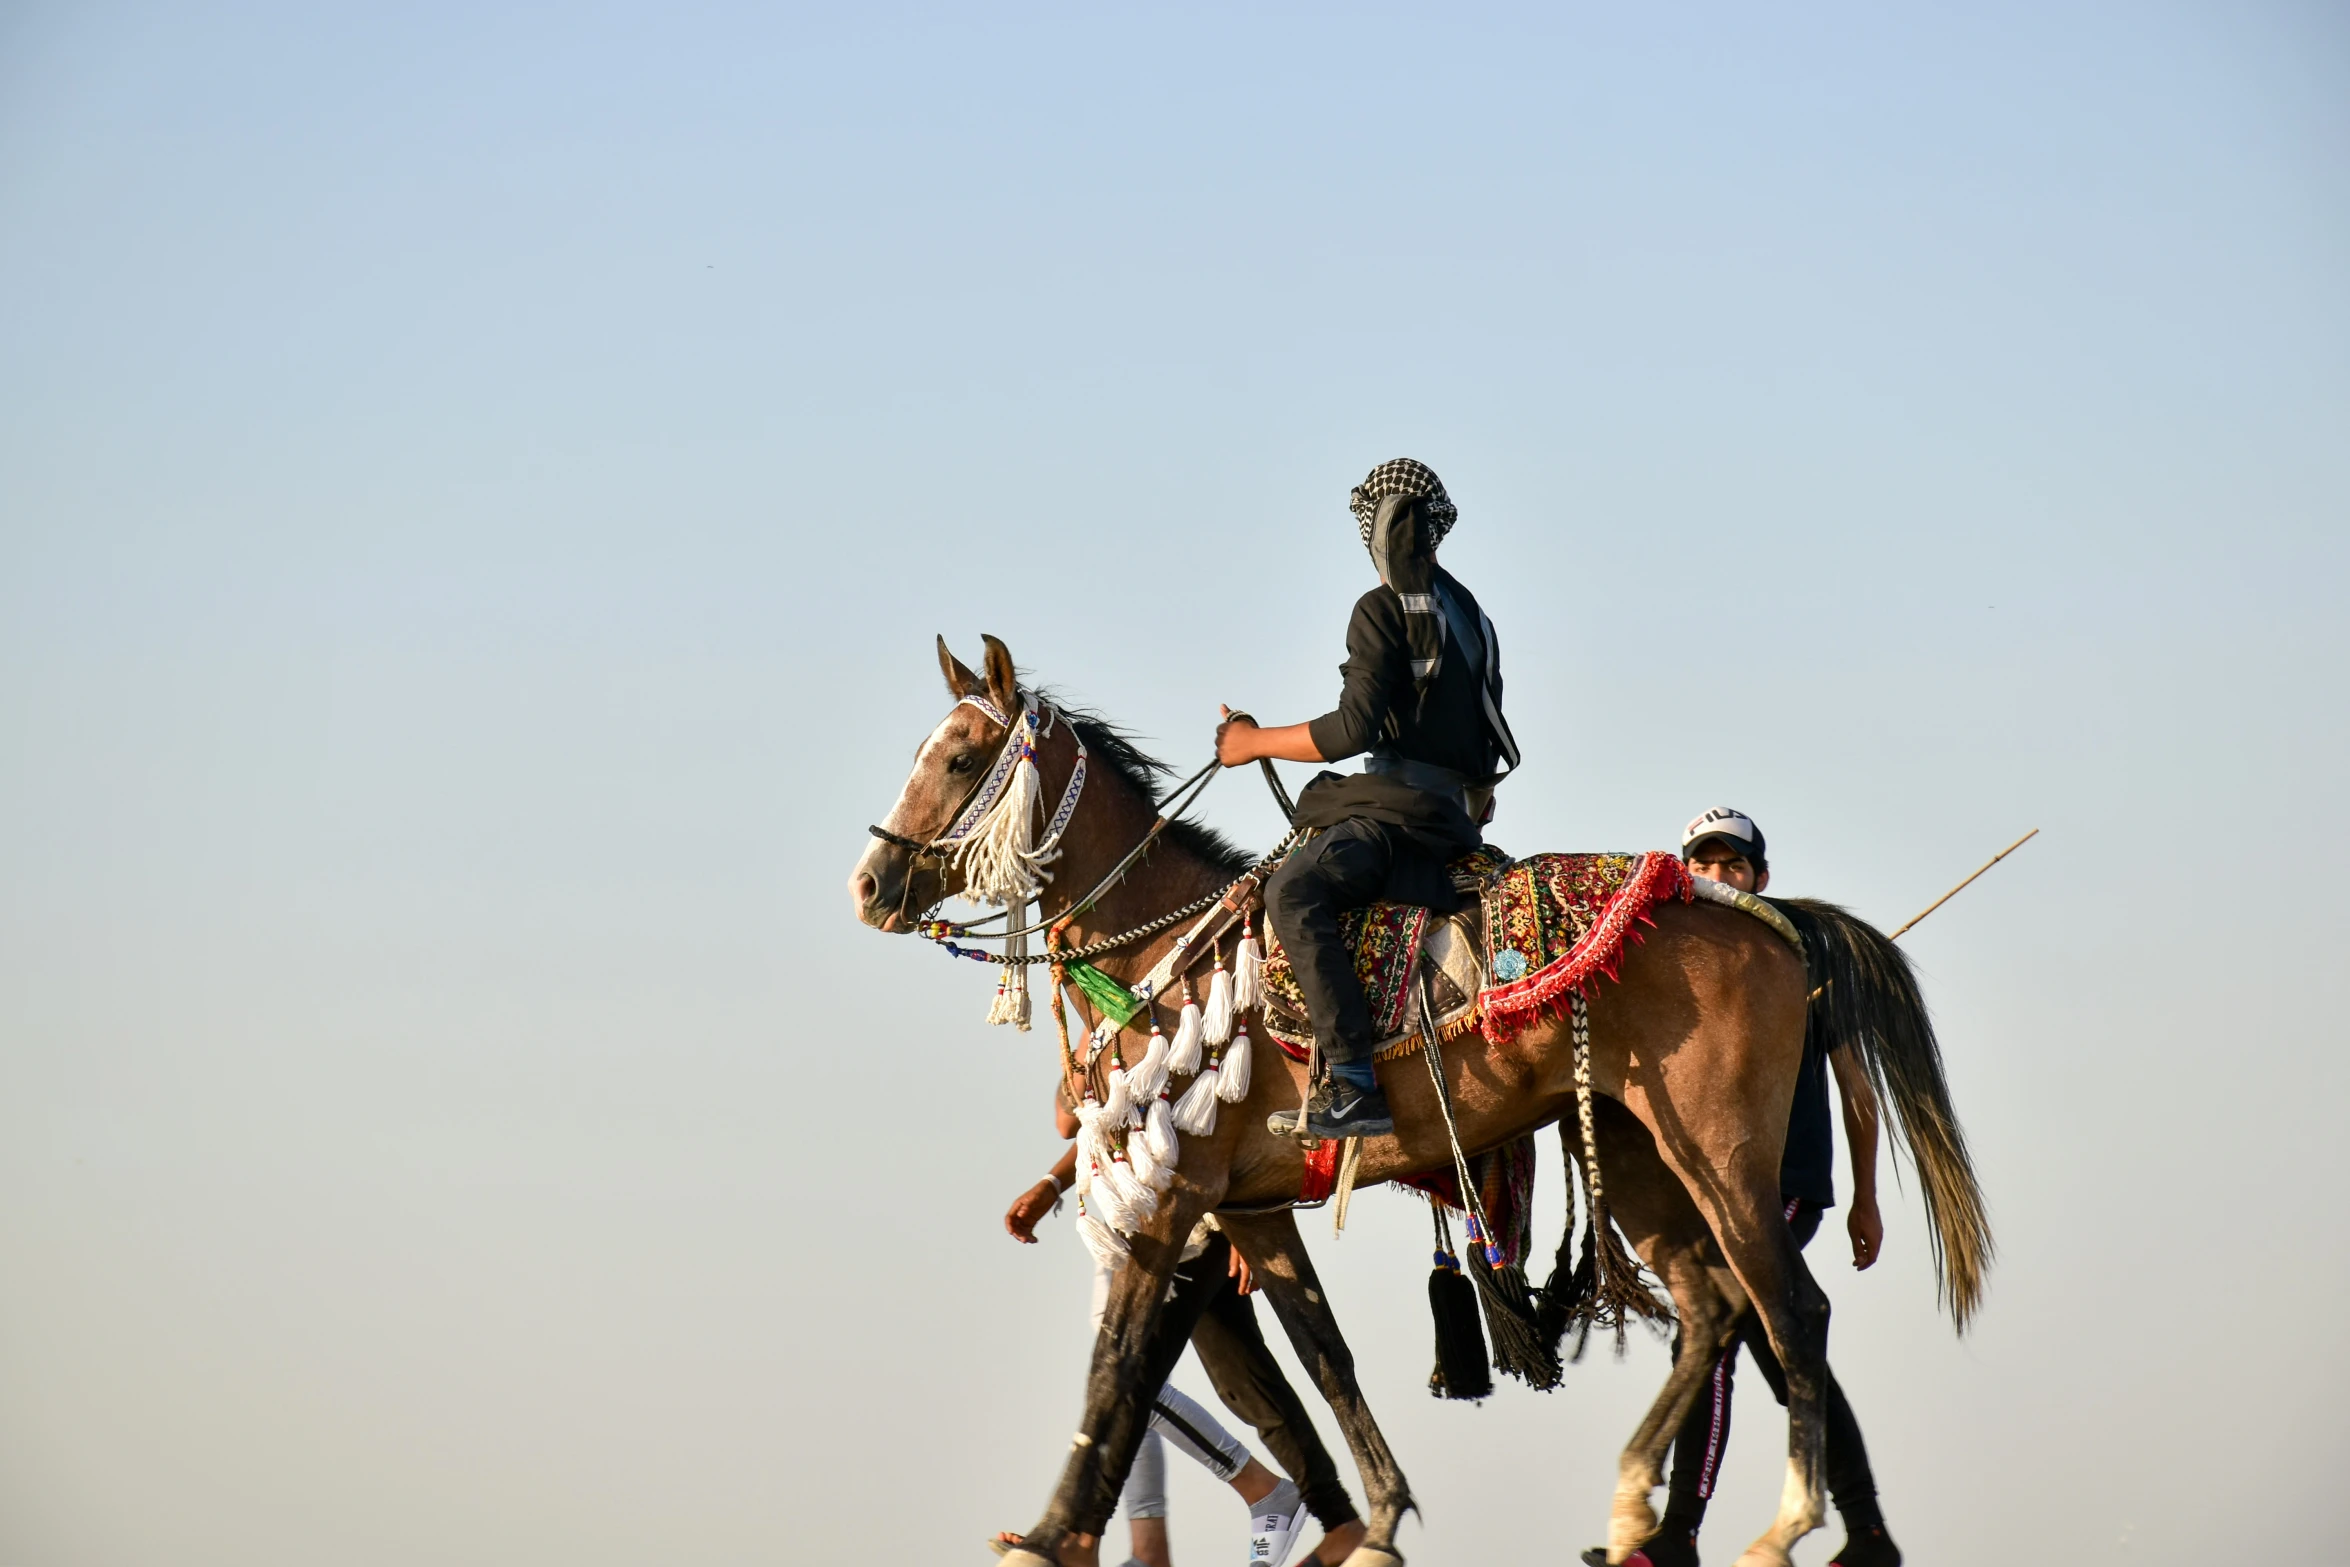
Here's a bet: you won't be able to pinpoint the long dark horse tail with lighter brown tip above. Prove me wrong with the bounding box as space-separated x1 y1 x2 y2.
1772 897 1995 1332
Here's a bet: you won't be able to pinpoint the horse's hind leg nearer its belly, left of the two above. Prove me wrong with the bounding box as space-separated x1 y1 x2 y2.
1588 1097 1746 1562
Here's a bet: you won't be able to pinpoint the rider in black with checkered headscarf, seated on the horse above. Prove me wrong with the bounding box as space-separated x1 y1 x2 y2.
1215 458 1518 1137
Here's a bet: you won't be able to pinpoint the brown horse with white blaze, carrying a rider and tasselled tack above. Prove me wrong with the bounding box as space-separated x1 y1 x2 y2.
848 637 1990 1567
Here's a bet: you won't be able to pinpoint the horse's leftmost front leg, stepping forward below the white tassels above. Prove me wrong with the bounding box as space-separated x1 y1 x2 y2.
1003 1179 1210 1567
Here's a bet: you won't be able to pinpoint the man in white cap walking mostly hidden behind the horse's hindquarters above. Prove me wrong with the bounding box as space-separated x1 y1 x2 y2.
1584 806 1901 1567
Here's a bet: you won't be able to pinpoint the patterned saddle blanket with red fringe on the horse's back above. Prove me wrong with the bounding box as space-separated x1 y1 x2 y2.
1264 843 1710 1060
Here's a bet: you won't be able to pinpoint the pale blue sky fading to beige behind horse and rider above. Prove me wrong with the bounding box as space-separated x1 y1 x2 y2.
0 5 2350 1567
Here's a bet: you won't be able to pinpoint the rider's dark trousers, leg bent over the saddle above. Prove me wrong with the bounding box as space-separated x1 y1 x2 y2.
1264 818 1459 1067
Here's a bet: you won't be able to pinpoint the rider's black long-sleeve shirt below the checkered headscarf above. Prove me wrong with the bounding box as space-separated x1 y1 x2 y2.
1307 566 1502 780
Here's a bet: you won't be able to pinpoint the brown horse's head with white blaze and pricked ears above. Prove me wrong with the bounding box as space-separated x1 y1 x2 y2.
848 637 1020 930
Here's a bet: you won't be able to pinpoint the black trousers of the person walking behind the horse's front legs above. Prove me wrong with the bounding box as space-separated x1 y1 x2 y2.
1099 1236 1356 1534
